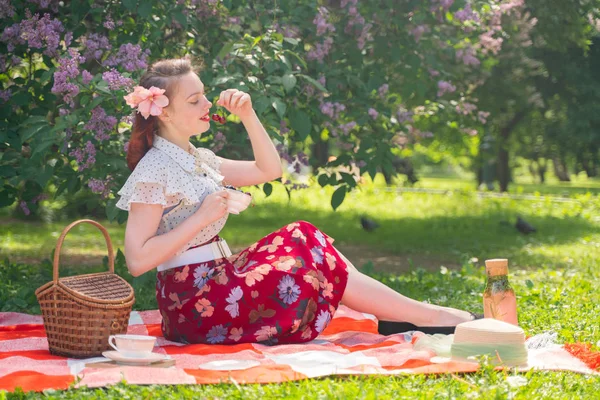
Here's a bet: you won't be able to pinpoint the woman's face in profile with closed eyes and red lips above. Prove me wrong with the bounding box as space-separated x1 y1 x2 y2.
165 72 212 137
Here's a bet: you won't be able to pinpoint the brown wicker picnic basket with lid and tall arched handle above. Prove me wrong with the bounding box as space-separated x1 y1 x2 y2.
35 219 135 358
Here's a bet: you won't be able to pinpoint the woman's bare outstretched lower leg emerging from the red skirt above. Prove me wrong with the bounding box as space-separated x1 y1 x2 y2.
338 251 473 326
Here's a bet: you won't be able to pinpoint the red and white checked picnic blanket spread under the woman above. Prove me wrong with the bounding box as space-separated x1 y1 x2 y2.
0 306 600 391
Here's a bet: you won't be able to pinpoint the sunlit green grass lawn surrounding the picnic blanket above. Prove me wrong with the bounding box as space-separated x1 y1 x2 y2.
0 180 600 399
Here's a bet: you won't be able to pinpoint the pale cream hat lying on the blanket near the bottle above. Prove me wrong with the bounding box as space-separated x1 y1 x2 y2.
451 318 527 365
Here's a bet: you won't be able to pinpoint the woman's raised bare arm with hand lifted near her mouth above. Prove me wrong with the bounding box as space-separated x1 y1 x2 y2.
217 89 283 186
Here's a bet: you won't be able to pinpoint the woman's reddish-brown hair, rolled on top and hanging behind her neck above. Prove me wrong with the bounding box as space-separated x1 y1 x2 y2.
127 57 198 171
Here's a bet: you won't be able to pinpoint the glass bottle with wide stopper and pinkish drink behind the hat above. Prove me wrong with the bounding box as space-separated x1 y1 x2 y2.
483 258 519 325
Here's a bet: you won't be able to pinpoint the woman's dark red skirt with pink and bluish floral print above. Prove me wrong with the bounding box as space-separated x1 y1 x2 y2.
156 221 348 344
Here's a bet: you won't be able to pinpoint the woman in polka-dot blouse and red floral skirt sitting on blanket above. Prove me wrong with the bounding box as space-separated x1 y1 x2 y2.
117 59 474 344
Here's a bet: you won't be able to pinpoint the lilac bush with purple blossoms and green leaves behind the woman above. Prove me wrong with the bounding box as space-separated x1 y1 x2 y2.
0 0 523 221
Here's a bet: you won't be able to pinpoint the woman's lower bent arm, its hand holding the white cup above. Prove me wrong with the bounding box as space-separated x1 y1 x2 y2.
125 191 228 276
